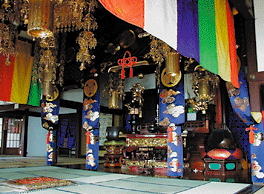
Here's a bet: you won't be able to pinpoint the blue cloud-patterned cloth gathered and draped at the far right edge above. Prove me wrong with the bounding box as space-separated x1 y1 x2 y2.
227 65 264 183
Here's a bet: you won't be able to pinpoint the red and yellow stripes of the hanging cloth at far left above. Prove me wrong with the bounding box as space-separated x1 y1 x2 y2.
0 40 33 104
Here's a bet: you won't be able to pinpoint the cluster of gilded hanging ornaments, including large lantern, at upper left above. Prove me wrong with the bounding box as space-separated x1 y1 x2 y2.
0 0 98 98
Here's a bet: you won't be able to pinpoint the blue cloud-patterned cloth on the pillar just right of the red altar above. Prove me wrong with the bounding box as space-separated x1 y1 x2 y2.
159 79 185 177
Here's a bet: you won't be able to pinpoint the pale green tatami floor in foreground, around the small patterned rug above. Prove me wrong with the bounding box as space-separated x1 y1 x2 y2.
0 166 250 194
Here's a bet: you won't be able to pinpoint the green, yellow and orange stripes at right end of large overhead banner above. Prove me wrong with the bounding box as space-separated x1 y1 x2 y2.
198 0 239 88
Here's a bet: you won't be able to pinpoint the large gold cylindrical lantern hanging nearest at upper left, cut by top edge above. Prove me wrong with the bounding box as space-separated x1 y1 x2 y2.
28 0 55 38
